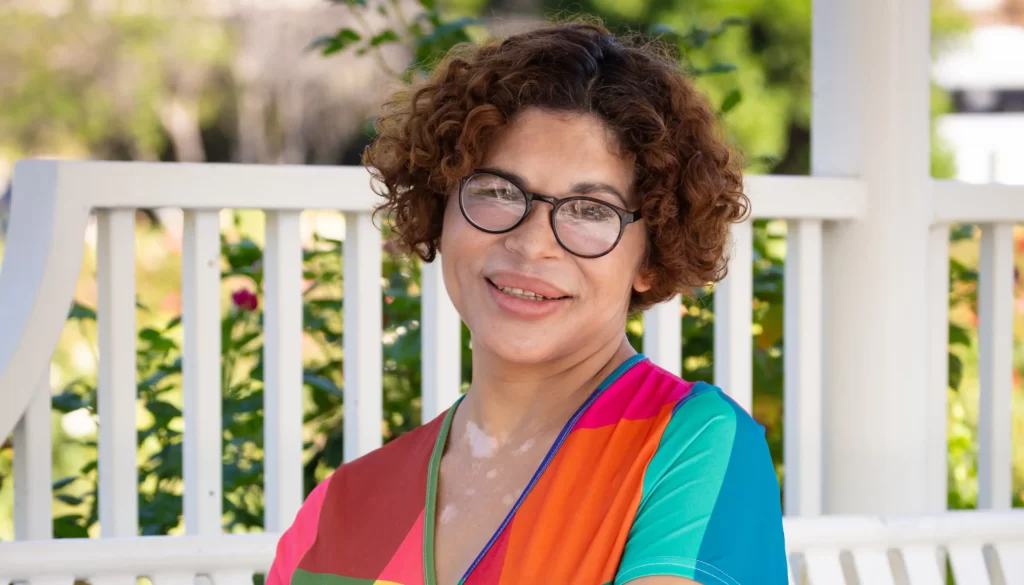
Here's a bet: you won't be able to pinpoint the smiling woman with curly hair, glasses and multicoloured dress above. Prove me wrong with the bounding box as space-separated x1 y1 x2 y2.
269 19 786 585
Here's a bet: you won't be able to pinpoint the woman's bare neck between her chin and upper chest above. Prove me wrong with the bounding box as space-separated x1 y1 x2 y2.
458 334 636 443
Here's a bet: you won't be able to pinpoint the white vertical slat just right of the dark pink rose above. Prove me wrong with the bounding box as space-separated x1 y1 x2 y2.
263 211 303 532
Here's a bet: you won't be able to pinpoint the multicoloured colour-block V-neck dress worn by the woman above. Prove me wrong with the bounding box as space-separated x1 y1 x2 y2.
267 356 787 585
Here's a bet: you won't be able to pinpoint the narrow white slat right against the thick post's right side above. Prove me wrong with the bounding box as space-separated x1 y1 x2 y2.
921 223 949 510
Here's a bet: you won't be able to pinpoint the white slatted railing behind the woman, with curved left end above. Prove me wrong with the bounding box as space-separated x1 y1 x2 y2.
0 155 1024 539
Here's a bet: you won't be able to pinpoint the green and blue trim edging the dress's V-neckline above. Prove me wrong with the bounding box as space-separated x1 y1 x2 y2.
423 353 646 585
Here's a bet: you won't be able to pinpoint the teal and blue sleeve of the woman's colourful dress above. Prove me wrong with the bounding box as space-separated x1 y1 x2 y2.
614 384 787 585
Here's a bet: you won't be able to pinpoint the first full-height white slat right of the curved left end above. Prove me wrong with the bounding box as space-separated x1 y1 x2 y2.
96 209 138 537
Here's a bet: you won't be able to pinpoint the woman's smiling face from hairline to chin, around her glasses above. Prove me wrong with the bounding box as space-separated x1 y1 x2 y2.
440 109 649 364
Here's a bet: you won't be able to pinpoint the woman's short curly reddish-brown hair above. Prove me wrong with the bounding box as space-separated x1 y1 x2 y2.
364 18 750 310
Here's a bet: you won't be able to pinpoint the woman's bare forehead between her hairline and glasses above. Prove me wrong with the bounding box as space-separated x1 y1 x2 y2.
481 109 633 197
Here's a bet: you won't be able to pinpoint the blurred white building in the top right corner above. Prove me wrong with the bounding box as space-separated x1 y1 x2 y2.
933 0 1024 184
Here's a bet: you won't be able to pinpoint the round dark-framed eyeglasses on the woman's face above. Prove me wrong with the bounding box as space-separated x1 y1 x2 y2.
459 170 640 258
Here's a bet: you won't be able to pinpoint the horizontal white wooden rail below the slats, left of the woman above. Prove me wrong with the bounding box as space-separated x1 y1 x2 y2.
0 533 281 581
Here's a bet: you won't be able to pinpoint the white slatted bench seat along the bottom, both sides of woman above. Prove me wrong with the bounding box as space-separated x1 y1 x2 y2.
0 510 1024 585
